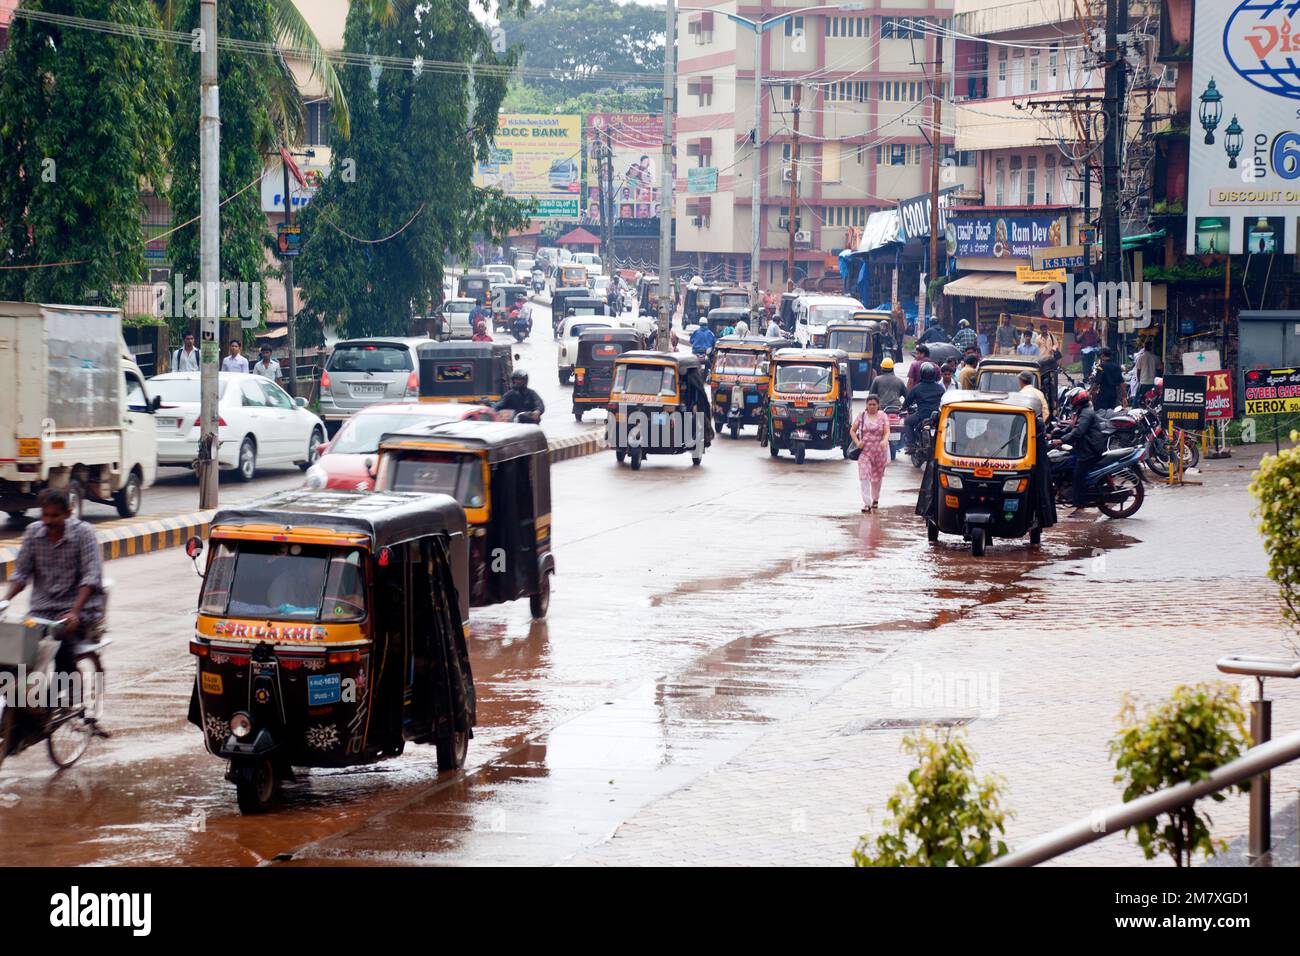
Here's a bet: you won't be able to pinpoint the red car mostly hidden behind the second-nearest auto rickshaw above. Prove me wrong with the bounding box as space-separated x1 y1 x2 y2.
307 402 497 492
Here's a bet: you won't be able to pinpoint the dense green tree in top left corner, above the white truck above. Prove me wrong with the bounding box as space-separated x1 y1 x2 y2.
0 0 169 304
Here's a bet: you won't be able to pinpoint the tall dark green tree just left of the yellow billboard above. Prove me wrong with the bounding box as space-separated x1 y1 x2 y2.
295 0 527 336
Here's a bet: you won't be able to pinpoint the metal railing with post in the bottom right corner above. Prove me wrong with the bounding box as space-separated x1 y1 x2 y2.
988 657 1300 866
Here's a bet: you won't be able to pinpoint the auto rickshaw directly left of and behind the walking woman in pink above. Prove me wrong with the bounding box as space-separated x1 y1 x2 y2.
759 349 853 464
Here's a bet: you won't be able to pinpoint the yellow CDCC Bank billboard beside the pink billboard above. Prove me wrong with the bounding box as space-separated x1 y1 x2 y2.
475 113 582 220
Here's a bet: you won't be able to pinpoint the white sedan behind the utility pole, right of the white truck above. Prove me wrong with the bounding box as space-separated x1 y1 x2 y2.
150 372 325 481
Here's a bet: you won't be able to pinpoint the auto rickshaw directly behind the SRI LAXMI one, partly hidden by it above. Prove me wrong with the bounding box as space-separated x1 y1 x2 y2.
374 421 555 619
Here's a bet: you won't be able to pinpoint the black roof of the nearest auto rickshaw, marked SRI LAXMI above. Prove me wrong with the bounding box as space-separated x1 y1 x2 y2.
212 488 465 548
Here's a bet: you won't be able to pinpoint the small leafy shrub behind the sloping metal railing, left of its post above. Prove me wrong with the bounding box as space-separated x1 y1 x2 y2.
1110 682 1249 866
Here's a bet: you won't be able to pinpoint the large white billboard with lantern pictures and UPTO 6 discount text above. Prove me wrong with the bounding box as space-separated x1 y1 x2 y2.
1187 0 1300 255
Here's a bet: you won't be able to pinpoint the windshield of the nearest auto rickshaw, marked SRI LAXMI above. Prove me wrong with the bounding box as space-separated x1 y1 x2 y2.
199 541 365 622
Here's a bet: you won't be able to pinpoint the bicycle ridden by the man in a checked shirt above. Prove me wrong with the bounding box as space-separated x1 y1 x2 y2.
0 601 112 767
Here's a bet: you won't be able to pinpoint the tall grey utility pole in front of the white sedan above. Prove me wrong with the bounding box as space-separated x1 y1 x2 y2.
195 0 221 511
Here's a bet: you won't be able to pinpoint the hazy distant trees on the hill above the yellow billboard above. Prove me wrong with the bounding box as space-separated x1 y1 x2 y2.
501 0 664 101
